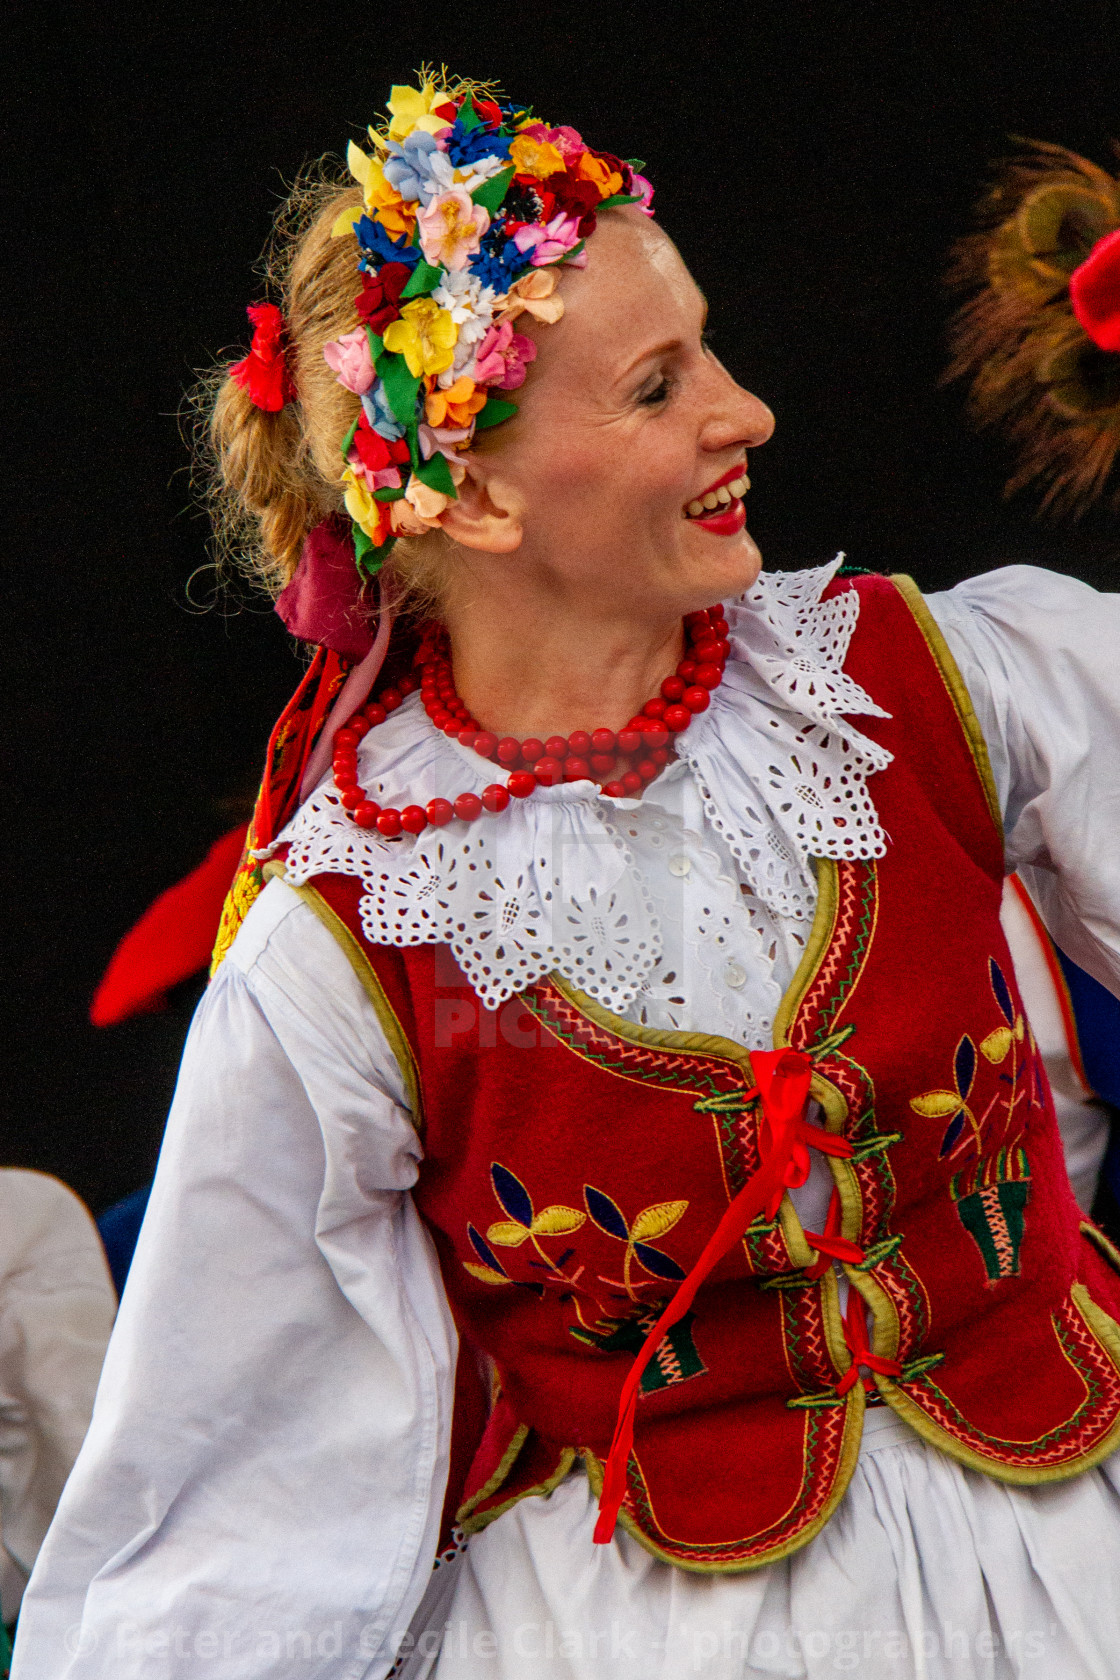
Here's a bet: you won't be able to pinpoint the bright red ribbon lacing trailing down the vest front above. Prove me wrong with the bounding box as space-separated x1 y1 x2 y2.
594 1050 859 1546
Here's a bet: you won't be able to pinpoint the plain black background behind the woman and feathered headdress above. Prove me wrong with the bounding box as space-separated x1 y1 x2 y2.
0 0 1120 1211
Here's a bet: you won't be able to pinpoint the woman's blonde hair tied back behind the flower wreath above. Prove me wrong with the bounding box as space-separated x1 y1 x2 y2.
191 158 452 612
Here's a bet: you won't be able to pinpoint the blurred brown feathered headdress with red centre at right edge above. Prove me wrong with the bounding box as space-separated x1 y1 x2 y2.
945 141 1120 514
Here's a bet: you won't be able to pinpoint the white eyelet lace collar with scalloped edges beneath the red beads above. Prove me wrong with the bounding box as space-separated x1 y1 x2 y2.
277 556 890 1013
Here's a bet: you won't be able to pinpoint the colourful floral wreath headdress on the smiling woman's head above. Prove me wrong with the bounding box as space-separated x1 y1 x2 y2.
315 71 653 576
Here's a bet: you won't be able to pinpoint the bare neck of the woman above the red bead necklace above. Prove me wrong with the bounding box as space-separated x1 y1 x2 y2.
443 581 683 739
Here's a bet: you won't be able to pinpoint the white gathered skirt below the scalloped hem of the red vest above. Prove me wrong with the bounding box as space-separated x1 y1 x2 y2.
409 1408 1120 1680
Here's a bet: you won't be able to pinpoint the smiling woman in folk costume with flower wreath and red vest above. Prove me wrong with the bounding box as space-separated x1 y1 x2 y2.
15 77 1120 1680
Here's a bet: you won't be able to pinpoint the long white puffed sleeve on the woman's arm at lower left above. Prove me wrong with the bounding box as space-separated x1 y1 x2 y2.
13 880 457 1680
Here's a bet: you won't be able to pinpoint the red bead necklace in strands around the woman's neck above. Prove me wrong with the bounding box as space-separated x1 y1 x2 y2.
334 606 729 840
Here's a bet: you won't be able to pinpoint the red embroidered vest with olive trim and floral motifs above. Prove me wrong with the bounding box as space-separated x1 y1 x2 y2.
282 578 1120 1571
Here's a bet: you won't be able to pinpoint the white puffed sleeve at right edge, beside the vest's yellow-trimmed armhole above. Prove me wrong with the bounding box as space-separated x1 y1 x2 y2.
929 566 1120 993
